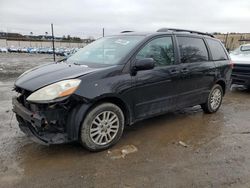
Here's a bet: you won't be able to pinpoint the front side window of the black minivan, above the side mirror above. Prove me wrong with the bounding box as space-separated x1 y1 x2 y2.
136 37 174 66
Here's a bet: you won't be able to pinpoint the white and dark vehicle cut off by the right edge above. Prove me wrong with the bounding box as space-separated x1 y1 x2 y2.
230 44 250 88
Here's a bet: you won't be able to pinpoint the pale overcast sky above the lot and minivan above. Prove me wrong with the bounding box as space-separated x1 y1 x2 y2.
0 0 250 37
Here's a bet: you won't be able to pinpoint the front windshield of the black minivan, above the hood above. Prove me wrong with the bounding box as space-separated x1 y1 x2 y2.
67 36 143 65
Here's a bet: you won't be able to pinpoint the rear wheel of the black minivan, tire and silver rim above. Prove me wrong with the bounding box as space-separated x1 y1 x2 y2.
201 84 223 114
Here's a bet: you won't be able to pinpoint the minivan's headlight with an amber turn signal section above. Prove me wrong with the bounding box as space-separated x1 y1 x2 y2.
27 79 81 102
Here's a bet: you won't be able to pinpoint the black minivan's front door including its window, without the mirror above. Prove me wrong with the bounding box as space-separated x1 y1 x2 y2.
133 36 180 119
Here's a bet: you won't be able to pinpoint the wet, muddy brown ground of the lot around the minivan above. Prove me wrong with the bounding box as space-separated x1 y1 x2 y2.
0 54 250 188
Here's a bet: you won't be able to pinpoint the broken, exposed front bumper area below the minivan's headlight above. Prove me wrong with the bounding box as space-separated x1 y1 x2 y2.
12 97 70 145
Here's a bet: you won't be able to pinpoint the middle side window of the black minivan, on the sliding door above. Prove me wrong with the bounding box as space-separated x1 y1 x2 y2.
177 37 208 63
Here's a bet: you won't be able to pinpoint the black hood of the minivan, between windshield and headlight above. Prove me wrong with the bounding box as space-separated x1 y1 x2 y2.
15 62 100 91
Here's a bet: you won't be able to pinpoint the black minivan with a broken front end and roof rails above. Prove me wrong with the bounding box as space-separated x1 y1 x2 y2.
13 28 232 151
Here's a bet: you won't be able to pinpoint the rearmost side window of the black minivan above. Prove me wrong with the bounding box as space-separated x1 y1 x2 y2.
206 39 228 61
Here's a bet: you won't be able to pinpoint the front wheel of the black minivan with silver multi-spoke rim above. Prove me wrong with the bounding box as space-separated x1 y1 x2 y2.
80 103 124 151
